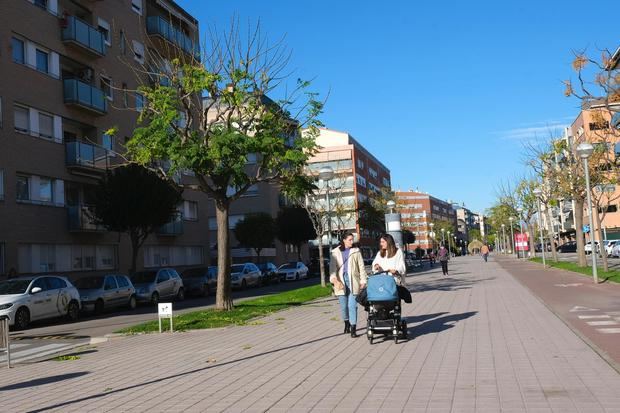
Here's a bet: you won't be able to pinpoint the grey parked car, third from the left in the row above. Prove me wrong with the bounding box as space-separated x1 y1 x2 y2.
131 268 185 304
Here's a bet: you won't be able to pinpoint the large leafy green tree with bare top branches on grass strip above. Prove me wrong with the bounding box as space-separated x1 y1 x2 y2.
127 23 323 310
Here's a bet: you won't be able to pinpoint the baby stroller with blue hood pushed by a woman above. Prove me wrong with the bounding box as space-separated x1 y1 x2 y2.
366 273 407 344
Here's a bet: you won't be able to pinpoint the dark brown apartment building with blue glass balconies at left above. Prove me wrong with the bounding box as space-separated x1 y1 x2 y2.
0 0 208 277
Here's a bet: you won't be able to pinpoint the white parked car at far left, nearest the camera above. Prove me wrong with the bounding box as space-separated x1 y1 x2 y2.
0 275 80 330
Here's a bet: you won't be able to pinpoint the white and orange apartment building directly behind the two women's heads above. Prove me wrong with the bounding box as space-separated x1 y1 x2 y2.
308 128 391 255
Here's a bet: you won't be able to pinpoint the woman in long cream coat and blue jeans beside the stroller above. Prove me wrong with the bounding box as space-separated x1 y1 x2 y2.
329 232 366 337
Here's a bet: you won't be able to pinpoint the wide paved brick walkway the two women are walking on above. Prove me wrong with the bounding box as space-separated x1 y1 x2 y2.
0 257 620 413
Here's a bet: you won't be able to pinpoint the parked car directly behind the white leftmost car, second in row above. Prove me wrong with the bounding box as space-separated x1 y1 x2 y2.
74 274 137 314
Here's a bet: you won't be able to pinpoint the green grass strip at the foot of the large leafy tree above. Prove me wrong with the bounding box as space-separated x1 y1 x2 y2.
117 285 331 334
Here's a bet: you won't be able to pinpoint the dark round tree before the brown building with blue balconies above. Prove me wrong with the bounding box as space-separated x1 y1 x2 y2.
91 164 183 273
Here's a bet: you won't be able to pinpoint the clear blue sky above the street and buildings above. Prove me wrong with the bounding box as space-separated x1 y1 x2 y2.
178 0 620 211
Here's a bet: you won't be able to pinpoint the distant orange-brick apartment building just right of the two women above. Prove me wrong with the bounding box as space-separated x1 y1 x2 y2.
395 190 457 251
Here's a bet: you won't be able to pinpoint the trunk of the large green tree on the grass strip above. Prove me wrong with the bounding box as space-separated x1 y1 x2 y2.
215 200 233 311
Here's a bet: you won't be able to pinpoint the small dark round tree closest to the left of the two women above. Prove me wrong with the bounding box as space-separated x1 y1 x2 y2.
276 206 316 261
